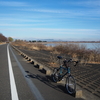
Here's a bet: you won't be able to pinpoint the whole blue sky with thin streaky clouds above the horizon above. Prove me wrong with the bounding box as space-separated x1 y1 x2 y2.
0 0 100 41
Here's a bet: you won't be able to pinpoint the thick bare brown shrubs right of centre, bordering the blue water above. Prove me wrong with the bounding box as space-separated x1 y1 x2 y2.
53 44 100 62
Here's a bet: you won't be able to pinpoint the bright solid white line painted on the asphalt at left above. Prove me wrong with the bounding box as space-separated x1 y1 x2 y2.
7 45 19 100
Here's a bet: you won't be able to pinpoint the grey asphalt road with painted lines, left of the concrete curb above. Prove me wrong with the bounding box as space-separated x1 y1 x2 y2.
0 44 83 100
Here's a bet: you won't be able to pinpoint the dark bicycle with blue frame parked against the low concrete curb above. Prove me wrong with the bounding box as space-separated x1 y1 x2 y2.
52 56 78 94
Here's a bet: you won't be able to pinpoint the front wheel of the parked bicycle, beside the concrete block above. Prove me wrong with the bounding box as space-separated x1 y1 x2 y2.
65 75 76 94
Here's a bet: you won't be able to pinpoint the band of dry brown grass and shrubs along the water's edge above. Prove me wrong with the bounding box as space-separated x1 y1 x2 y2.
12 40 100 63
